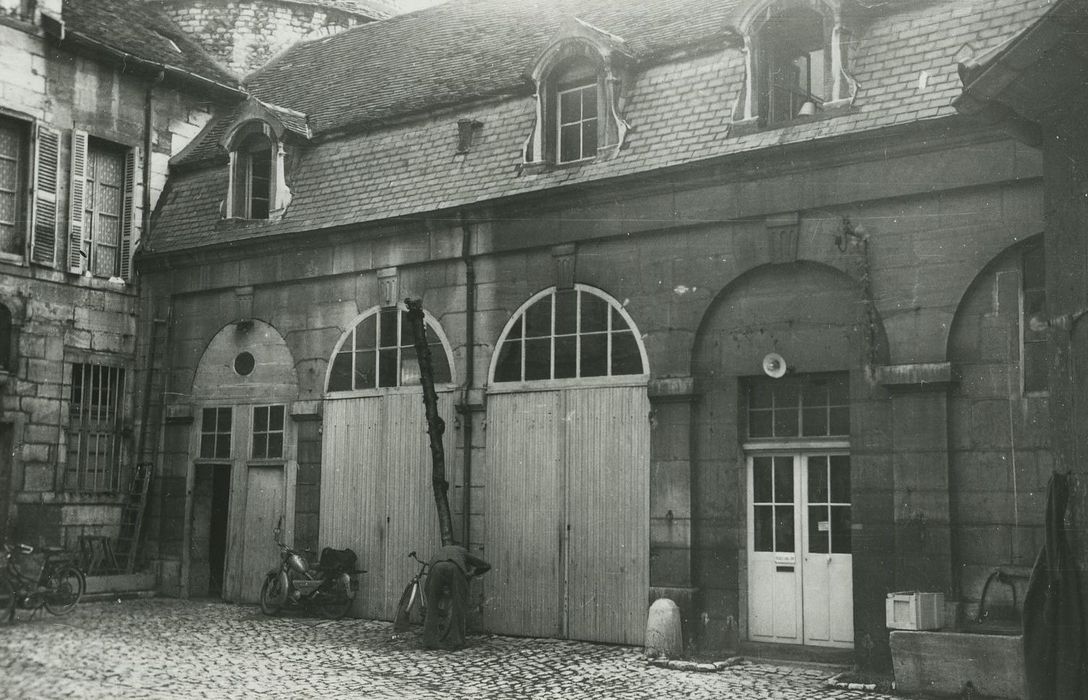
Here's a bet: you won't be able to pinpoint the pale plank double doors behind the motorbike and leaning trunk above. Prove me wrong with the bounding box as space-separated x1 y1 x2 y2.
319 391 454 619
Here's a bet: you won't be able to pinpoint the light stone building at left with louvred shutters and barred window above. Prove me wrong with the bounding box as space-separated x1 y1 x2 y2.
0 0 240 549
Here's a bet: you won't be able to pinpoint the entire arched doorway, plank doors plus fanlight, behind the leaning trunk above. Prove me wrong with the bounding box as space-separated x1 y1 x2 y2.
319 305 455 619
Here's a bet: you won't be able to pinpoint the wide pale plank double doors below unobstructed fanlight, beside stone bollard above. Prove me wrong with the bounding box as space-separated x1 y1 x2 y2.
484 386 650 644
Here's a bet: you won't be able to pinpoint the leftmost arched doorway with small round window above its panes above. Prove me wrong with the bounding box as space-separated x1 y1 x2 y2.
183 320 298 602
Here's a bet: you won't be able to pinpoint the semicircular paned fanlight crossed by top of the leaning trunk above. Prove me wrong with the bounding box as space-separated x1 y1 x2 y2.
327 306 453 392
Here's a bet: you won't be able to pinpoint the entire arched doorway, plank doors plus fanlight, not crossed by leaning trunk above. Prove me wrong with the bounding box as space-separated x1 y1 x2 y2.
484 284 650 644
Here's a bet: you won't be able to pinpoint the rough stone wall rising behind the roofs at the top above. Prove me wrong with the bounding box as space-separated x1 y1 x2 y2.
162 0 371 76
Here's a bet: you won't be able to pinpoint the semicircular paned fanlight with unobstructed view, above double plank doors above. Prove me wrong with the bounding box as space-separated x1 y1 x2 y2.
492 284 648 383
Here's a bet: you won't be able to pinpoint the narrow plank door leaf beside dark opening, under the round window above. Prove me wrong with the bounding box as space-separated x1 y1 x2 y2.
239 465 284 603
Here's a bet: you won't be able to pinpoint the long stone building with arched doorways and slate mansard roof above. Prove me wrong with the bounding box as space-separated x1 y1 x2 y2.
137 0 1052 662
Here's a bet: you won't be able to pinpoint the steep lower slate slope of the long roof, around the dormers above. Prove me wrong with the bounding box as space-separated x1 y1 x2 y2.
151 0 1047 251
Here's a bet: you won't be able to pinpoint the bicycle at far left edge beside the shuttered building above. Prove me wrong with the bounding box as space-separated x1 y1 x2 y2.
0 543 87 623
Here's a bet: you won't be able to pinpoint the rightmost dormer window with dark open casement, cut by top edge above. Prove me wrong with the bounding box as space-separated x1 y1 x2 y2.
733 0 856 126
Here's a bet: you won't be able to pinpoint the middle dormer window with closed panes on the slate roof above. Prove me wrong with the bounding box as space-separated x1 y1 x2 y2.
526 20 628 167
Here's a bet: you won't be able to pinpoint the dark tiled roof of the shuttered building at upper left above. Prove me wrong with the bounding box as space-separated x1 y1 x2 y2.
63 0 238 86
